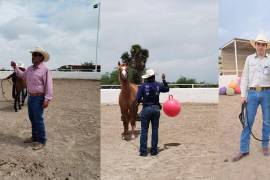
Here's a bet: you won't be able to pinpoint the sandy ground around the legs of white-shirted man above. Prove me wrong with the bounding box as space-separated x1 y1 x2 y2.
218 96 270 180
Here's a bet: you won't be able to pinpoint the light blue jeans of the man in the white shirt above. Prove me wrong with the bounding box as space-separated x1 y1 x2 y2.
240 90 270 153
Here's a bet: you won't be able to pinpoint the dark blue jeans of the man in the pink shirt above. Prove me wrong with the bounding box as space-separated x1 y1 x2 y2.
28 96 46 144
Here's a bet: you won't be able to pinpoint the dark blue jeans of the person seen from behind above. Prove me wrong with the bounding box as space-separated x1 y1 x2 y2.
140 105 160 154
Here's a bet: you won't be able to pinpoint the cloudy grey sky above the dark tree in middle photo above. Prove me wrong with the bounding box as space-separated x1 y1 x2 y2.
100 0 218 83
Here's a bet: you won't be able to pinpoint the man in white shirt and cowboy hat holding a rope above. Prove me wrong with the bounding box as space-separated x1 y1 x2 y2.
233 33 270 162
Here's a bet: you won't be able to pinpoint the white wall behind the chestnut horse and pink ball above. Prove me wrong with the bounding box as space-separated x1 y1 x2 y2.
100 88 218 105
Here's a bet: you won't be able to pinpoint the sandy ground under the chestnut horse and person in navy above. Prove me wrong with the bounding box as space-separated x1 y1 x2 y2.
101 103 219 180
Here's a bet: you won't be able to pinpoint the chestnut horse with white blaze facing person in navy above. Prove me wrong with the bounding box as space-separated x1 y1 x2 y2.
118 62 138 140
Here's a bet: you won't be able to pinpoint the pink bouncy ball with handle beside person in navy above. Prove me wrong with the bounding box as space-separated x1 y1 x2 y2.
163 95 181 117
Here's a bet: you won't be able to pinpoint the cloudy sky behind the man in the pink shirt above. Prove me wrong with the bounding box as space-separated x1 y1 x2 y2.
0 0 98 69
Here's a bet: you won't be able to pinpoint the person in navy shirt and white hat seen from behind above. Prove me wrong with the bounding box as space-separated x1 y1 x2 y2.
136 69 169 156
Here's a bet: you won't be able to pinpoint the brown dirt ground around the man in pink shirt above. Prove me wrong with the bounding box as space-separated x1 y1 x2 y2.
0 80 100 180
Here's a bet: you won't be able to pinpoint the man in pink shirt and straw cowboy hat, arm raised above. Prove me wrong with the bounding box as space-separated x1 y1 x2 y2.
11 47 53 150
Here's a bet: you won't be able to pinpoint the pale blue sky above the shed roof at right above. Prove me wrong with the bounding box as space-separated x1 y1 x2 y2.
219 0 270 47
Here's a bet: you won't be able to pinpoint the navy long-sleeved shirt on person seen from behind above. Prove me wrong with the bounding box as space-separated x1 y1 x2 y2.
136 80 169 107
